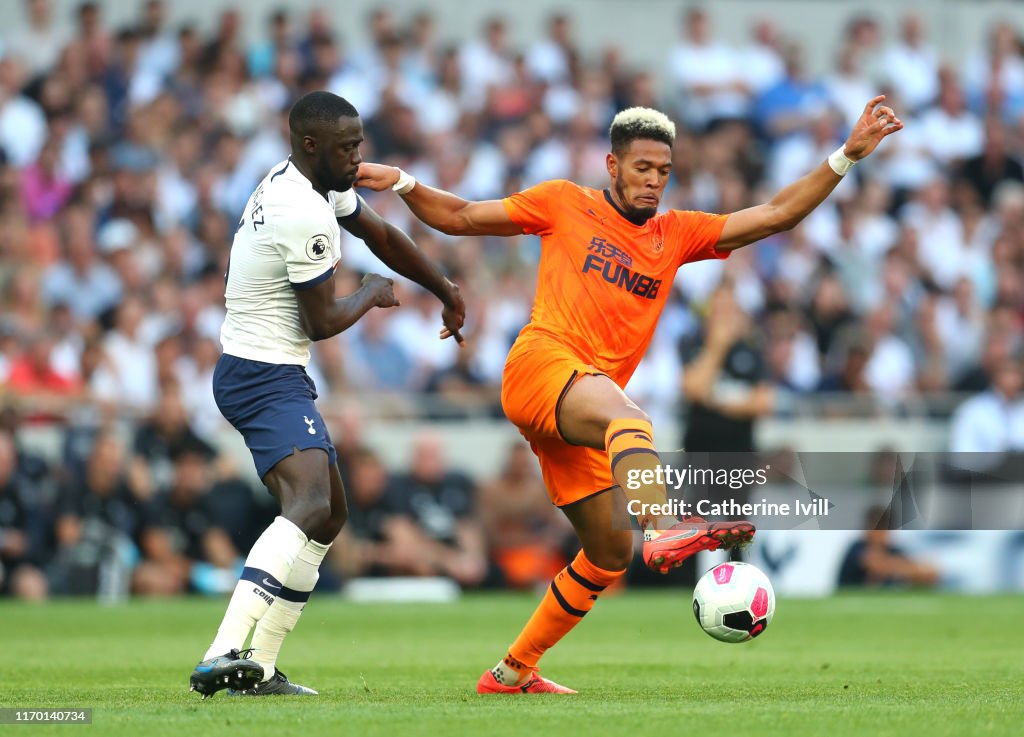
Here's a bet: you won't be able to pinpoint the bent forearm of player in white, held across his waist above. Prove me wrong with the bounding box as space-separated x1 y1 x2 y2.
295 274 398 341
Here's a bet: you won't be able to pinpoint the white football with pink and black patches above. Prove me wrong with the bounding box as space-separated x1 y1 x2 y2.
693 563 775 643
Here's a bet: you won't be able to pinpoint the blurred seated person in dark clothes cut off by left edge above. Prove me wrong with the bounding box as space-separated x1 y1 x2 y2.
0 431 50 601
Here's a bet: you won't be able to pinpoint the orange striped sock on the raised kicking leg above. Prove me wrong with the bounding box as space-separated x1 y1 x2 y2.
604 418 674 529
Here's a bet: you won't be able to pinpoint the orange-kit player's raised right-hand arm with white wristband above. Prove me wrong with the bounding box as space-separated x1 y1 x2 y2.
715 95 903 251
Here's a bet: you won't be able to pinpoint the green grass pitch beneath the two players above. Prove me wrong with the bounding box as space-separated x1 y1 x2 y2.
0 592 1024 737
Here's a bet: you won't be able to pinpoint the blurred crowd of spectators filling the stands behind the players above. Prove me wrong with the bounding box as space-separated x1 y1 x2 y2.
0 0 1024 598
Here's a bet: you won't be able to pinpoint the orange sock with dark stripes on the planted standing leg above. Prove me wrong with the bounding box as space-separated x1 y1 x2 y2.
492 551 626 686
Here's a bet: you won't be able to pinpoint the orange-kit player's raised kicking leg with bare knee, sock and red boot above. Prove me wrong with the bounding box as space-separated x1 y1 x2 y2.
558 376 754 573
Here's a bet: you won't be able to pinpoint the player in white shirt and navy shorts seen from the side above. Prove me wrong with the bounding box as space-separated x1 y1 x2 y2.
189 92 465 698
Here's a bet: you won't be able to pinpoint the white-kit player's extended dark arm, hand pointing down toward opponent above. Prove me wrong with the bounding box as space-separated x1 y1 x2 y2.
338 198 466 343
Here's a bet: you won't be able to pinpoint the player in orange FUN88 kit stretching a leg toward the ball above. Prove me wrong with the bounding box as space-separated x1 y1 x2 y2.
356 95 903 693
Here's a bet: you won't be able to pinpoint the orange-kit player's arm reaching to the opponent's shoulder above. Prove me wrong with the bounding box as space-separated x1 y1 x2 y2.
355 162 522 235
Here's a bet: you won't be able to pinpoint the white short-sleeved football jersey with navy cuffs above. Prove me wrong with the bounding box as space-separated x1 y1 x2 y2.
220 159 360 366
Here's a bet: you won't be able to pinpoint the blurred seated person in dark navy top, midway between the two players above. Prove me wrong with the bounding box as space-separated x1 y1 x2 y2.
389 431 489 587
